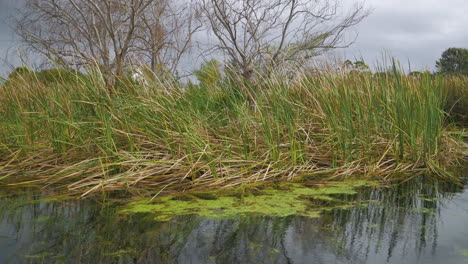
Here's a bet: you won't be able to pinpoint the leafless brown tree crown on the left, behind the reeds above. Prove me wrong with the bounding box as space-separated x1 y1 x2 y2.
15 0 198 78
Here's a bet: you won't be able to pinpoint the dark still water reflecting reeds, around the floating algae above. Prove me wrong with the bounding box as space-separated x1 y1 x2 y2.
0 178 468 264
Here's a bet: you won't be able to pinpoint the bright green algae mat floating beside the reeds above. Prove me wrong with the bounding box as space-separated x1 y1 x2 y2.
121 181 373 221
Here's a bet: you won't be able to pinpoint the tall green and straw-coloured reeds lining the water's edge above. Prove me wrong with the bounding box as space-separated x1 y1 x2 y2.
0 67 468 195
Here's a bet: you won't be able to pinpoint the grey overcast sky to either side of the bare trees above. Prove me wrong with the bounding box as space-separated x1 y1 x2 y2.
0 0 468 74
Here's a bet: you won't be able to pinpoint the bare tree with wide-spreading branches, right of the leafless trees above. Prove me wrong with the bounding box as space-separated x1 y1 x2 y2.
200 0 368 79
